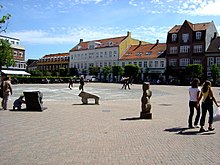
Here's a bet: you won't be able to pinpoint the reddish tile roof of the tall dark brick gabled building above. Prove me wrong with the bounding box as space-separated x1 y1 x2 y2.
168 21 211 33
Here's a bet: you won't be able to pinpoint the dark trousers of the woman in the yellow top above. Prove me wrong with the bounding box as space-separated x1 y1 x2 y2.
200 102 213 126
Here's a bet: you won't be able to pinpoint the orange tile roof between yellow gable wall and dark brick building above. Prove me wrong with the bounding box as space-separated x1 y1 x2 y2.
120 43 166 60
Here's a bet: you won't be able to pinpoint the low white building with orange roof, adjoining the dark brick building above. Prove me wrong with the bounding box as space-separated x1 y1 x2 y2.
119 40 166 83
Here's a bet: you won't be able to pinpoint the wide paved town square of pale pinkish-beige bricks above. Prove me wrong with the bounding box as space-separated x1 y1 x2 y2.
0 83 220 165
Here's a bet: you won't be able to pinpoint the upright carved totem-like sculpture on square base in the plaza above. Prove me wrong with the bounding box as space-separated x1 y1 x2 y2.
140 82 152 119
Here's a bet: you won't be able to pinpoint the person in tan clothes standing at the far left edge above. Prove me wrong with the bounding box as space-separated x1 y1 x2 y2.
2 76 12 110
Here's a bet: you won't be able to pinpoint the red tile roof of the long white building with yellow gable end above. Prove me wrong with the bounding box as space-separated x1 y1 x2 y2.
70 36 127 52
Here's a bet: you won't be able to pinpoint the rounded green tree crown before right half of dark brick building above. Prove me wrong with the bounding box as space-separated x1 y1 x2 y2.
185 64 203 78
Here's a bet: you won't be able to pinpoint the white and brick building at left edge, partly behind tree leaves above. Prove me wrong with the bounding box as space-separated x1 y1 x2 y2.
0 35 26 70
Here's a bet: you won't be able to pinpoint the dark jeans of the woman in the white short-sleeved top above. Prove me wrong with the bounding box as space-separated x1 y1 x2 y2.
188 101 200 126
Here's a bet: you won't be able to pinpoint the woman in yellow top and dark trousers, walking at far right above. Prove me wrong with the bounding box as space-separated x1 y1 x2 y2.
197 80 219 132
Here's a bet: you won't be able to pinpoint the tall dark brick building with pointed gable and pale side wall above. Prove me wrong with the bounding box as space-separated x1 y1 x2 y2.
166 20 218 79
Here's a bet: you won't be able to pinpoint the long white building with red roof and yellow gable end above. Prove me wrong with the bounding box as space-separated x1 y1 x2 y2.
69 32 148 74
